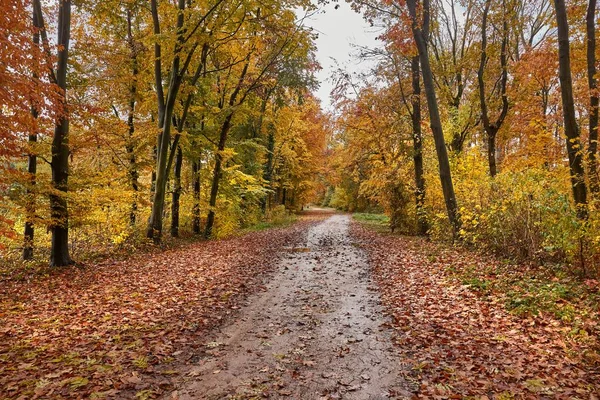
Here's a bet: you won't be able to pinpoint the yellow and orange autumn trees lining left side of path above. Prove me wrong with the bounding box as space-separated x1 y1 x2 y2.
3 0 328 266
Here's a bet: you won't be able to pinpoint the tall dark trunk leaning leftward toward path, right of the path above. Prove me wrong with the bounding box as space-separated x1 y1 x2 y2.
406 0 460 237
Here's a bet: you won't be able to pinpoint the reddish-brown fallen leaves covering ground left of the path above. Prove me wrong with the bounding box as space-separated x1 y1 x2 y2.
0 218 318 399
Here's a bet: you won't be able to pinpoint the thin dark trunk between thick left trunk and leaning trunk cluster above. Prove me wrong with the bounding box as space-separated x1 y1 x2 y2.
125 10 139 226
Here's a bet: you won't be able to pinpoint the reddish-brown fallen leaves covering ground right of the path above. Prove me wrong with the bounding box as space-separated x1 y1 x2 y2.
352 223 600 399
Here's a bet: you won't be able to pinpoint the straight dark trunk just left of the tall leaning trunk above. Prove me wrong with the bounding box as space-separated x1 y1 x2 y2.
410 55 429 235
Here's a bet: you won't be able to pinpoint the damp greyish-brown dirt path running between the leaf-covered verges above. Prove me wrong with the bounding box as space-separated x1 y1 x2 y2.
167 215 408 399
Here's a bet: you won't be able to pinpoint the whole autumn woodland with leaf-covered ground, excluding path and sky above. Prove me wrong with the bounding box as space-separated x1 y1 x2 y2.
0 0 600 399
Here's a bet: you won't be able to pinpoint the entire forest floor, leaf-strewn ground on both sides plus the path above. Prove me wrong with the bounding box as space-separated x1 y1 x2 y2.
0 211 600 400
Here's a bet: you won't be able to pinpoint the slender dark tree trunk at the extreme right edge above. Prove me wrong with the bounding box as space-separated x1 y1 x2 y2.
586 0 600 196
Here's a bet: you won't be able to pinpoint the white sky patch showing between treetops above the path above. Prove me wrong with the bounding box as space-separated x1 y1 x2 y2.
305 0 380 109
